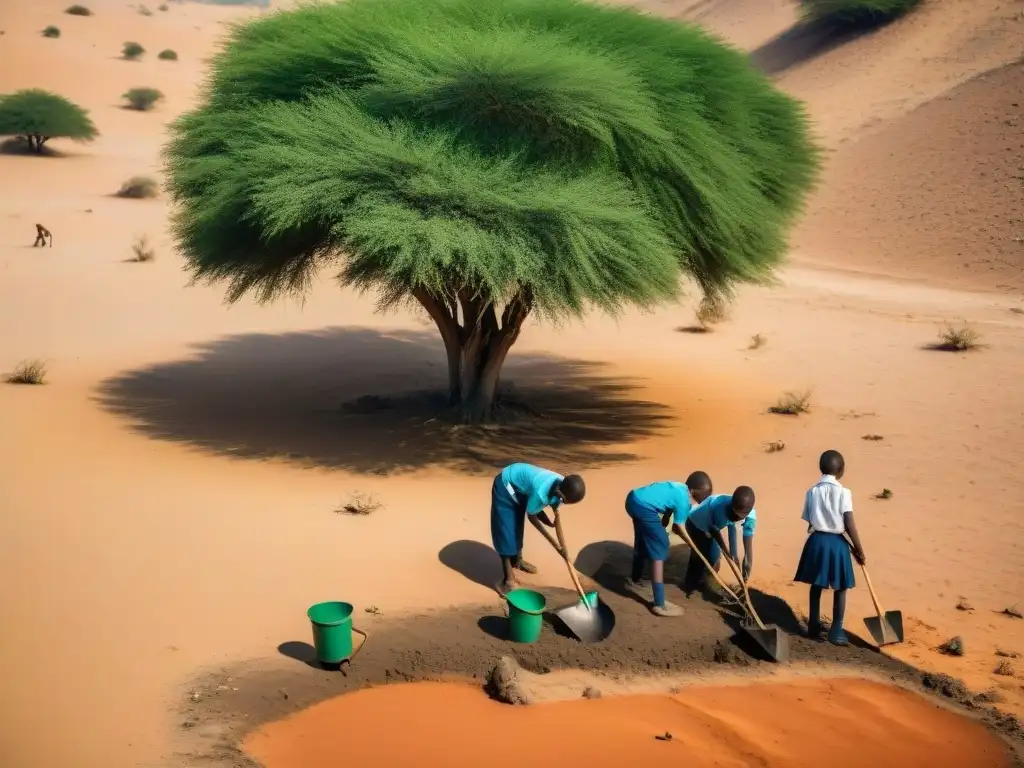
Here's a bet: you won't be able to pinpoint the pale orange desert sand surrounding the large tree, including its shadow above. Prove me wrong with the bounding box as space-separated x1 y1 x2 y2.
0 0 1024 768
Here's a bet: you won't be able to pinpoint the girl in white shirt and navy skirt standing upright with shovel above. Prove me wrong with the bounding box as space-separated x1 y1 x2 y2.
794 451 864 645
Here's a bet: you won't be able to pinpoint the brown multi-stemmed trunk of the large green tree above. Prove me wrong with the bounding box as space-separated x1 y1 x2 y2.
414 289 532 424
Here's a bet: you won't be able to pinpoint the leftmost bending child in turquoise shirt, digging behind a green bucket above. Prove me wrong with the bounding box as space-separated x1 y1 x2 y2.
490 463 587 592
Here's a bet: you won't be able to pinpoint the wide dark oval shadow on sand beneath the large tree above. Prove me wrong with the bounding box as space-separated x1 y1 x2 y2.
96 328 671 475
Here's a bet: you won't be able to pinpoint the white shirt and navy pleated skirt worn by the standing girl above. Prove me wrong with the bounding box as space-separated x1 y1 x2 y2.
794 475 856 591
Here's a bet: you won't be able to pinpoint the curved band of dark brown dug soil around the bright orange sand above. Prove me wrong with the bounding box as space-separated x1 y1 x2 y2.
172 542 1024 768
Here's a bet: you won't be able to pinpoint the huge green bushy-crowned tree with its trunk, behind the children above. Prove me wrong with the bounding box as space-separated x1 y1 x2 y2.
167 0 818 422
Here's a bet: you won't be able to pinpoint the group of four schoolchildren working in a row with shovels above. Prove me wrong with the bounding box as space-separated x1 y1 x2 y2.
490 451 864 645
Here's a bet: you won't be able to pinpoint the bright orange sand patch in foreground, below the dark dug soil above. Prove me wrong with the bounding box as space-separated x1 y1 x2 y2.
245 680 1011 768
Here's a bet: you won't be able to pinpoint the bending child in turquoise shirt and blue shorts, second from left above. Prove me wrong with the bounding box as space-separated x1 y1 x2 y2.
626 472 712 616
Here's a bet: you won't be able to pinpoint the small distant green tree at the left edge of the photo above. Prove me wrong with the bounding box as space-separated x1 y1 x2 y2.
0 88 98 154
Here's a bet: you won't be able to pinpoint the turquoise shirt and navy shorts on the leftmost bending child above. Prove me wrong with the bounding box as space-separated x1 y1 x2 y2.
490 464 562 557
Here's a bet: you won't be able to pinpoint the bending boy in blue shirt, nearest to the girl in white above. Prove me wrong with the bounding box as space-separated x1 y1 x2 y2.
683 485 758 597
